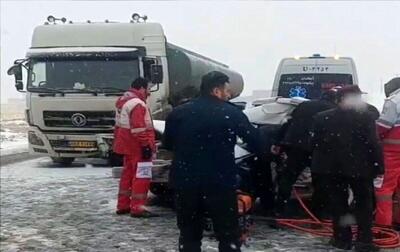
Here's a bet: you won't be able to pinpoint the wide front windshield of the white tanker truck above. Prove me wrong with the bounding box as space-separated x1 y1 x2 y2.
28 58 139 92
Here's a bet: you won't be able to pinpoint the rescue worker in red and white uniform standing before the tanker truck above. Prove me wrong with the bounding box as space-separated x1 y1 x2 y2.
113 78 156 217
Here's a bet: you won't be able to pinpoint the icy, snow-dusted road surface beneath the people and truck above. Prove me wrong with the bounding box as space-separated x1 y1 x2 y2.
0 158 394 252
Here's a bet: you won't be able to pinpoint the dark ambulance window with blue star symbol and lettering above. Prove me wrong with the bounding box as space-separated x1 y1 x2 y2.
278 74 353 99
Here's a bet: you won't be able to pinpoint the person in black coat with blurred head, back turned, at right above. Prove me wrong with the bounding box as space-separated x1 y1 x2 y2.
312 86 384 251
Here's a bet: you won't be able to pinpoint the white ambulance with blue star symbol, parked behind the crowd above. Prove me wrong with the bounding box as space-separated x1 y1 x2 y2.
272 54 358 99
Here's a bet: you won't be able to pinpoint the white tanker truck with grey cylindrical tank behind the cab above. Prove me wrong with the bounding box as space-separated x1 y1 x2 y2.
8 14 243 164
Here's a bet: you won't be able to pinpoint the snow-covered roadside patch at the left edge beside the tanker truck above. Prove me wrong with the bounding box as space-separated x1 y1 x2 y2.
0 120 28 156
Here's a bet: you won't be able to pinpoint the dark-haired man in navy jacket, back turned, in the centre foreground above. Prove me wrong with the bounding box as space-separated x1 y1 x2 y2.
163 71 260 252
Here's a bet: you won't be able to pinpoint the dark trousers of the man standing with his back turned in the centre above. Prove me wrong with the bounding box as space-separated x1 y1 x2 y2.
176 184 240 252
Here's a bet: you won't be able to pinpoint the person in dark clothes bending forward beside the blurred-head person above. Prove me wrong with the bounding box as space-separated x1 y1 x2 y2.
275 89 336 215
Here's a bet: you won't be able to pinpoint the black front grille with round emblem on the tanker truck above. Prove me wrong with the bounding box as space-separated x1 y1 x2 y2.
43 111 115 128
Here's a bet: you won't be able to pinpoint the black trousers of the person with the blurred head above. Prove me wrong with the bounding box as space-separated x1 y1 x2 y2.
324 175 374 243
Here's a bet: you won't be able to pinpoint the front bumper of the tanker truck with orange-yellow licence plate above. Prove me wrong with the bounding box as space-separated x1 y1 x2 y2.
28 126 108 158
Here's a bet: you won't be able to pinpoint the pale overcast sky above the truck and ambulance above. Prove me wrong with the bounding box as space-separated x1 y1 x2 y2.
1 1 400 102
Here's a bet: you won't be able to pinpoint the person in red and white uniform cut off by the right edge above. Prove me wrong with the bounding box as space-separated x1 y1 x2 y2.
375 78 400 226
